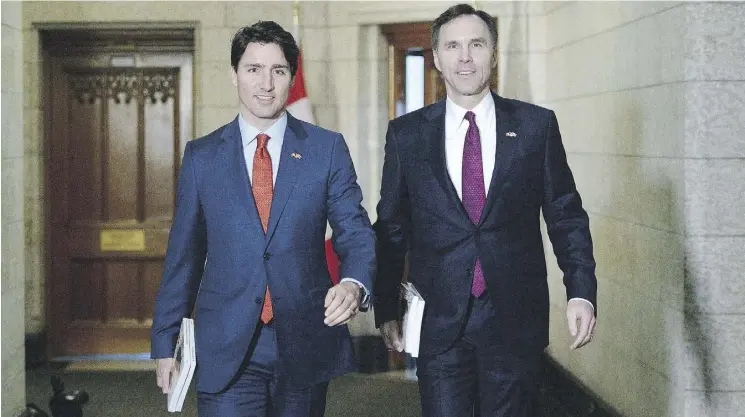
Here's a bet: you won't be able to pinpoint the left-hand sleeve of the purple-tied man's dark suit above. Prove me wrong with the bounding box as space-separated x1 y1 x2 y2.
373 123 411 327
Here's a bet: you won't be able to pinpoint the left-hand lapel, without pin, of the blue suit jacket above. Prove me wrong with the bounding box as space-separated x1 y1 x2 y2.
220 117 264 235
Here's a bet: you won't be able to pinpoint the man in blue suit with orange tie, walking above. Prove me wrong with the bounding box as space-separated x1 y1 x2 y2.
152 22 375 417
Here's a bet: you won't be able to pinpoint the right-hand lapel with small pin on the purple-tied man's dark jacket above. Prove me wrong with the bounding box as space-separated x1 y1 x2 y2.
479 93 520 224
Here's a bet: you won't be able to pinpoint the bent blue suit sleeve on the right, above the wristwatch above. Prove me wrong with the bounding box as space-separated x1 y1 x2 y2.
328 135 375 291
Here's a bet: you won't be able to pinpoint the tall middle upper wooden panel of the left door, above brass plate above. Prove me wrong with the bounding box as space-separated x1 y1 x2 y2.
105 89 139 220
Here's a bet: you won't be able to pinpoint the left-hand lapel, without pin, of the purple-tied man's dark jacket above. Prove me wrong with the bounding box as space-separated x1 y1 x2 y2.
422 100 470 223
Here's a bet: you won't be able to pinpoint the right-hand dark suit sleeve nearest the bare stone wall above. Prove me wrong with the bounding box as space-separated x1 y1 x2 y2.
543 111 597 314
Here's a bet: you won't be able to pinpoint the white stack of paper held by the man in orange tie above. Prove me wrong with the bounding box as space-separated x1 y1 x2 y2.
168 318 197 413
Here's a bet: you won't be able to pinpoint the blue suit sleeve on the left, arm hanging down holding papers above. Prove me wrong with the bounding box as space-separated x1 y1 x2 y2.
151 142 207 359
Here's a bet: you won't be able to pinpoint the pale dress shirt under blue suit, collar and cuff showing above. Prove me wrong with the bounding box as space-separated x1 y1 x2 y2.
238 112 370 308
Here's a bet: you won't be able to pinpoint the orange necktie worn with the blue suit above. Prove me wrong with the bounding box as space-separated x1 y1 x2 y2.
251 133 274 323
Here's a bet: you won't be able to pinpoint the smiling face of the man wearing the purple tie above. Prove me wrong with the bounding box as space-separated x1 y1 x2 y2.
434 15 497 104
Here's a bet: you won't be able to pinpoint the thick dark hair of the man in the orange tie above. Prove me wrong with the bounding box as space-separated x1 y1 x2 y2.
230 20 300 77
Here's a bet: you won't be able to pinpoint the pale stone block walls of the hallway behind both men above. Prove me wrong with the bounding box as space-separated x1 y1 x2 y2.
2 1 745 417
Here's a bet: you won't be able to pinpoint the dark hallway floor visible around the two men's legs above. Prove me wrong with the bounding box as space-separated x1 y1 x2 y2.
26 354 610 417
